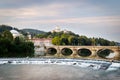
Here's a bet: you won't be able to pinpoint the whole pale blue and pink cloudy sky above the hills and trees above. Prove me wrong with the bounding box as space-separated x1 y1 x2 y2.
0 0 120 42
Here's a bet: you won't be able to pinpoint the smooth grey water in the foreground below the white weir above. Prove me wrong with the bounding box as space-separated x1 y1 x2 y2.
0 64 120 80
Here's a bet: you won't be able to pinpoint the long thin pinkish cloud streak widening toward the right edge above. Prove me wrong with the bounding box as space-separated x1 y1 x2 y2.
9 16 120 25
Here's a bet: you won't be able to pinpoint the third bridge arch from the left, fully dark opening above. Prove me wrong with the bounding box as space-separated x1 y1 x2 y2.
77 48 92 57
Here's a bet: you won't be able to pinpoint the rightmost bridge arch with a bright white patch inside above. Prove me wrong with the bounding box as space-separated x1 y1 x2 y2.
97 48 116 59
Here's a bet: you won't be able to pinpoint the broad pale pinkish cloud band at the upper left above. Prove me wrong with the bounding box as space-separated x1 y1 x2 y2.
0 4 62 18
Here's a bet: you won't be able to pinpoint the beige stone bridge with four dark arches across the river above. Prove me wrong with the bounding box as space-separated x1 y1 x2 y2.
45 46 120 60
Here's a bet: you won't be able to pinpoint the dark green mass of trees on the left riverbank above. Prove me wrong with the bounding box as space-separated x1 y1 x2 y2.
0 31 34 57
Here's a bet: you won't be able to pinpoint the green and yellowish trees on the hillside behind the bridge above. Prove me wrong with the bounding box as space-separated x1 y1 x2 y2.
36 32 116 46
